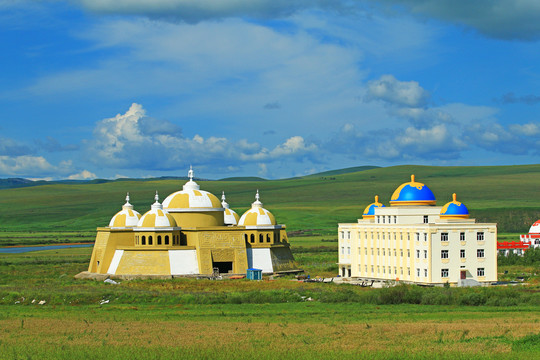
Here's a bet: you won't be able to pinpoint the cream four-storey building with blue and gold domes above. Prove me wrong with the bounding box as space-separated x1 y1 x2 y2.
338 175 497 285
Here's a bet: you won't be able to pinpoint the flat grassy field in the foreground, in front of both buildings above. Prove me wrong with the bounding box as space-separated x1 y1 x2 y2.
0 246 540 359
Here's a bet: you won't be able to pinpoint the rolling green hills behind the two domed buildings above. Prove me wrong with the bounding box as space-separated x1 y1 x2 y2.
0 165 540 236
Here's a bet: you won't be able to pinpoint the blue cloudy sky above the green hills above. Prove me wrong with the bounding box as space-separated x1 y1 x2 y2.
0 0 540 179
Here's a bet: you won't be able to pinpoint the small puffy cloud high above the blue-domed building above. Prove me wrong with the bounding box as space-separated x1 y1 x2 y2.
364 75 429 108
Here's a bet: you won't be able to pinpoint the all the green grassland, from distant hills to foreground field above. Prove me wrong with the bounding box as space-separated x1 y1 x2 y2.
0 165 540 359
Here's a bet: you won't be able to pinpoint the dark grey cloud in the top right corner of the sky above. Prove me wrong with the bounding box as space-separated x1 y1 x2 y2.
371 0 540 40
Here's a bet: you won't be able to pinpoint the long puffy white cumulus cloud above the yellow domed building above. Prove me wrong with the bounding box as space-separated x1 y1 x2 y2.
86 103 318 170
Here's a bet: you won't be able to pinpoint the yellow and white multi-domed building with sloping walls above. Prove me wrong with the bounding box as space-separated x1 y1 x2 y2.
88 169 295 277
